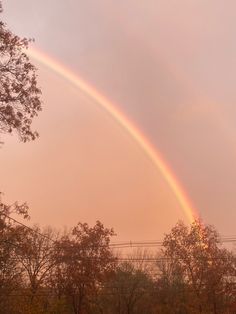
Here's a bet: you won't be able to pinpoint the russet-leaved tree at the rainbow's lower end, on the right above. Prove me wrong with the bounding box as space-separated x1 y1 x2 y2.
158 220 236 314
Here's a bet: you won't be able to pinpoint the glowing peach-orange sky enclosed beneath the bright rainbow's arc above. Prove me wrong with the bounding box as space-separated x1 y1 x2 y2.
0 69 187 240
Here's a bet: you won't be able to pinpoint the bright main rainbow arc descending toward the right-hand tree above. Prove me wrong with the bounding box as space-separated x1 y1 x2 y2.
27 48 197 223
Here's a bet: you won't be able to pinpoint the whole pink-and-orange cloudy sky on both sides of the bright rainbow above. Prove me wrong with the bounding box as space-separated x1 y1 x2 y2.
0 0 236 239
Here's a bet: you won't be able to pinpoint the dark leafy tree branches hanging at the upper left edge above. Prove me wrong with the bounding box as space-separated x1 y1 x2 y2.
0 2 41 142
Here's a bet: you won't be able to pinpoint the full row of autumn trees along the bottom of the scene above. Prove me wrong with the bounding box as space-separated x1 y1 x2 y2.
0 203 236 314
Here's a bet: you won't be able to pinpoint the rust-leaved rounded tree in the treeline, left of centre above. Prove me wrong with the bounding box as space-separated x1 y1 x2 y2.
52 221 116 314
